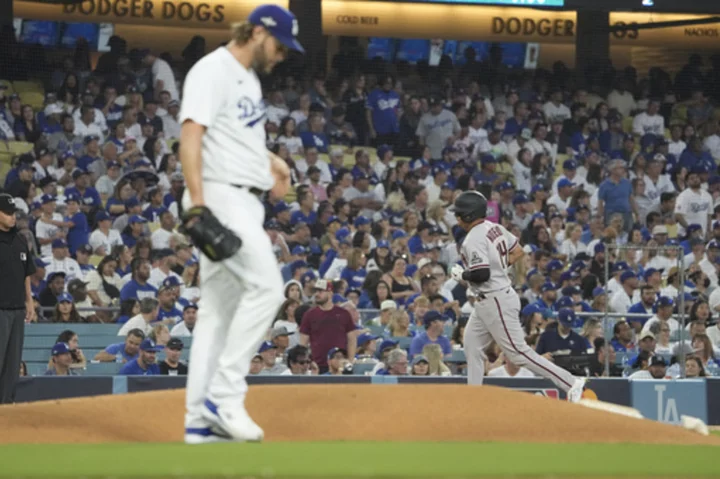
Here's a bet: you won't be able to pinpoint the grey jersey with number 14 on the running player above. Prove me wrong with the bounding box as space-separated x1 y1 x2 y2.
460 220 520 293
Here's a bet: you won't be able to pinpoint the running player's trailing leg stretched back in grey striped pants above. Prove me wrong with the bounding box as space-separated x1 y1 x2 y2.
475 288 575 392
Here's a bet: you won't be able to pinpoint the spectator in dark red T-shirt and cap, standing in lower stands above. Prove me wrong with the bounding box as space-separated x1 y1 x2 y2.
300 279 362 374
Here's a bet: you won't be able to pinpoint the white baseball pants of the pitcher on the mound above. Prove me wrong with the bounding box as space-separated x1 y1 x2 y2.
183 182 285 428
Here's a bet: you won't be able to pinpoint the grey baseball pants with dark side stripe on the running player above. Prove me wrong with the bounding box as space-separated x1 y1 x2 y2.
464 288 575 392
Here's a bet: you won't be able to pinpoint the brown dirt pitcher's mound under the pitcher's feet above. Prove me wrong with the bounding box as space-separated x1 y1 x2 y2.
0 385 720 445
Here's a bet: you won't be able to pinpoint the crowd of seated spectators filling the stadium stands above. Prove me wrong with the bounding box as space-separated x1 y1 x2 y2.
0 31 720 378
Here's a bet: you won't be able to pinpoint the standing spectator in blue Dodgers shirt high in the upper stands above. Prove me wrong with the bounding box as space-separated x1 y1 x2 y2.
367 75 400 146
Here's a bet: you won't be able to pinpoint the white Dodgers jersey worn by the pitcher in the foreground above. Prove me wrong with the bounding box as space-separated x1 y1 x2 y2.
180 47 274 190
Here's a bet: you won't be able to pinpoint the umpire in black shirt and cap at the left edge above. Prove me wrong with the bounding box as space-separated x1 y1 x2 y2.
0 193 35 404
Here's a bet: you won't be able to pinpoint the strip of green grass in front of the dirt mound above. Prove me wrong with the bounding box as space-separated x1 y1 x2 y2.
0 442 720 479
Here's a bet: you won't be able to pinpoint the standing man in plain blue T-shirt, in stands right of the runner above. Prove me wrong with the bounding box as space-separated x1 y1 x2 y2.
598 160 637 233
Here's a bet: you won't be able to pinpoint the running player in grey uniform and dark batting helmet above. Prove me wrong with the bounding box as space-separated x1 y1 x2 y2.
451 191 585 402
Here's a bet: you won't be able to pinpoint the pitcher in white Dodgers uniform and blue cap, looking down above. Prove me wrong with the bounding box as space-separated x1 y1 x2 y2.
180 5 304 444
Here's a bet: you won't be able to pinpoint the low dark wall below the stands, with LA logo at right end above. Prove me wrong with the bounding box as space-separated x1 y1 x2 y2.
16 376 720 425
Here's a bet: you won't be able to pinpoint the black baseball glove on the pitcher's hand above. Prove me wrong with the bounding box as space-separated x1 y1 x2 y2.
180 206 242 261
